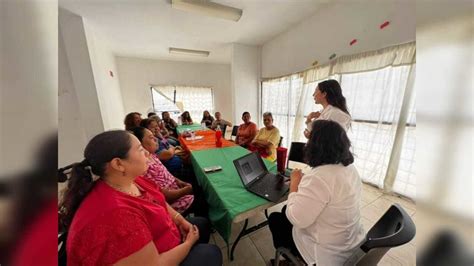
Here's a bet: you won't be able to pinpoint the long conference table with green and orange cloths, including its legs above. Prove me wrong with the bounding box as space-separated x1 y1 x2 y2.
179 130 285 260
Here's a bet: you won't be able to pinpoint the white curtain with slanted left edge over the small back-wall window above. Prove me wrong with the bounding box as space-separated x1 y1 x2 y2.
153 86 214 123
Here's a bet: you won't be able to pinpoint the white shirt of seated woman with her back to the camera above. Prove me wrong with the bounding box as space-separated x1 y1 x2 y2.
286 164 365 266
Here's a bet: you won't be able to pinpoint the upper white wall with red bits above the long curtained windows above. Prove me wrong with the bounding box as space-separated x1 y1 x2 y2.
262 1 416 78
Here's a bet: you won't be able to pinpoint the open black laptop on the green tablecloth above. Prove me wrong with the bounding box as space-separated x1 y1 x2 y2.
234 152 288 202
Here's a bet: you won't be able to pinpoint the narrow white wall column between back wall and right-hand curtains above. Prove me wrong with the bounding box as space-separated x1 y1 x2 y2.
231 44 260 124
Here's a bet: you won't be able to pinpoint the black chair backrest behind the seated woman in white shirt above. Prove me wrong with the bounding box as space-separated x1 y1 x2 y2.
345 203 416 265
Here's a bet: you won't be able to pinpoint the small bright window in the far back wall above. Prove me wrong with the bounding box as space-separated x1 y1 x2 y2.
151 86 214 123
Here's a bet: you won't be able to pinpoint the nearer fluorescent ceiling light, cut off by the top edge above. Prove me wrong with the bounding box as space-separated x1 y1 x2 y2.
171 0 243 21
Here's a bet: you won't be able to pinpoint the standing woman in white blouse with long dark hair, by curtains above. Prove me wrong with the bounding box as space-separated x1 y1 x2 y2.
304 79 351 138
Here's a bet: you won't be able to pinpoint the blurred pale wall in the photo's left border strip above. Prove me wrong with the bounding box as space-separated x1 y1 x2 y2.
0 1 58 179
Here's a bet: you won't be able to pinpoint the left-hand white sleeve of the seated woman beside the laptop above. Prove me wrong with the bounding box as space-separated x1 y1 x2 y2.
286 175 331 228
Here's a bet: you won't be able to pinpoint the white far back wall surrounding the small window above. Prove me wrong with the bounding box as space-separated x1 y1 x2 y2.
116 57 233 119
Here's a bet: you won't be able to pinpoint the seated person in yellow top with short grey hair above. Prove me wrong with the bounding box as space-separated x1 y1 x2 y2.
248 112 280 161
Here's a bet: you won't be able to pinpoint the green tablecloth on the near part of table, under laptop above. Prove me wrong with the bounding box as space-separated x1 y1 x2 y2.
191 146 277 242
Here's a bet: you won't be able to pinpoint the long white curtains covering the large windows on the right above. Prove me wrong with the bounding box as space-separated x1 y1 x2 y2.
262 42 416 197
